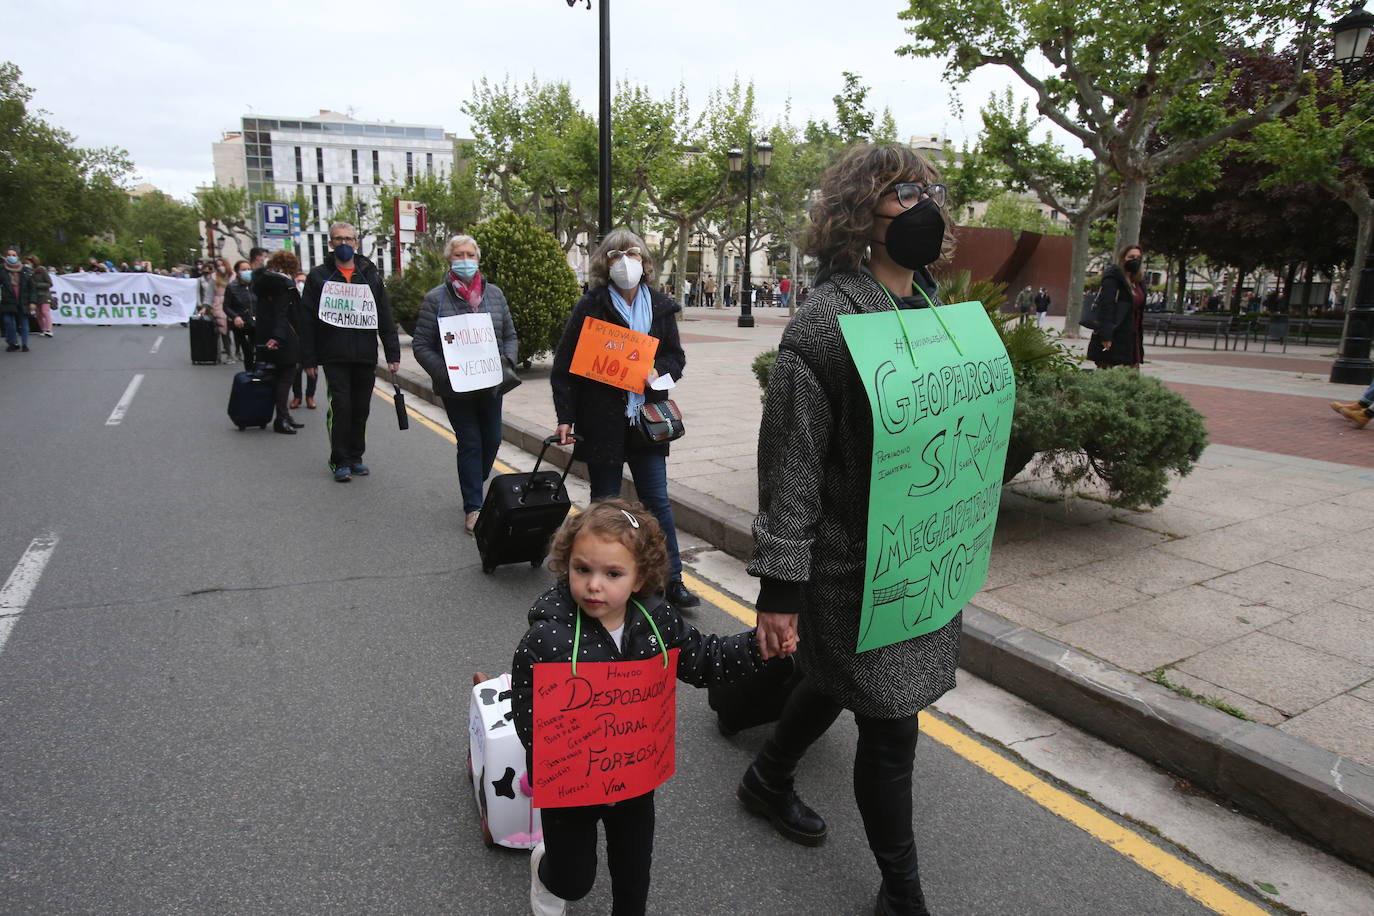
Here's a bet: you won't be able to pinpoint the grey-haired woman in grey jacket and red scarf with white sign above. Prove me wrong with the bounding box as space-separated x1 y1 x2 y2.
411 235 519 534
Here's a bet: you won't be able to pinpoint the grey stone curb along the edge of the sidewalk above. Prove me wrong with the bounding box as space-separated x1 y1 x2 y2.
376 367 1374 872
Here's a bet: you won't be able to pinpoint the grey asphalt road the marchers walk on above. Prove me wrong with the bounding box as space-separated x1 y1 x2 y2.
0 325 1275 916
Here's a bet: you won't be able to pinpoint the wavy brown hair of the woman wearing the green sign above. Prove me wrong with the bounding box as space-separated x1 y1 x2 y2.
807 143 954 271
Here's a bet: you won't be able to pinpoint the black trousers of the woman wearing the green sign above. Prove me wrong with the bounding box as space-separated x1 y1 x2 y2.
757 678 921 900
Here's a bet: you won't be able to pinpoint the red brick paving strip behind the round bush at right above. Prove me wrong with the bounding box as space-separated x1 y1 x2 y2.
1165 382 1374 467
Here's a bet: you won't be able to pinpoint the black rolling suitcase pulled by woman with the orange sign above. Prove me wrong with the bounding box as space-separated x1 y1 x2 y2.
473 435 576 573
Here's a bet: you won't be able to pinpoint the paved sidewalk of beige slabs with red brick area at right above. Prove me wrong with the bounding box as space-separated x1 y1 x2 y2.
384 309 1374 867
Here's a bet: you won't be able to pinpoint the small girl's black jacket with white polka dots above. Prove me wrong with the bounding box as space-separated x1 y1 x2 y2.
511 584 760 772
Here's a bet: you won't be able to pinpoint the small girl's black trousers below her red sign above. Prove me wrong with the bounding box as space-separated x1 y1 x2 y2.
539 792 654 916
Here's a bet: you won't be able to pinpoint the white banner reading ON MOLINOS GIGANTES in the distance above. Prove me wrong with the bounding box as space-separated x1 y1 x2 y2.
52 273 196 324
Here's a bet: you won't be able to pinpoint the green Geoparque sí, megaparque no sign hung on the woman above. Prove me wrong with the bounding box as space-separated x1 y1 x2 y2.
840 302 1017 652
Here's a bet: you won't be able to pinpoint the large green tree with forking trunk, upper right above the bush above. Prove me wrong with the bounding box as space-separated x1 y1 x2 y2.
897 0 1308 254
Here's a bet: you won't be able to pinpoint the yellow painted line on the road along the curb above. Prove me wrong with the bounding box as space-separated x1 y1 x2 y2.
376 390 1265 916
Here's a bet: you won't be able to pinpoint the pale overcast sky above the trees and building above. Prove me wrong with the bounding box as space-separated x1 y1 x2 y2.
13 0 1038 196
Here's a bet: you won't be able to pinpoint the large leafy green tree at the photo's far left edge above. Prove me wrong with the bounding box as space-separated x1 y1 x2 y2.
0 62 133 262
